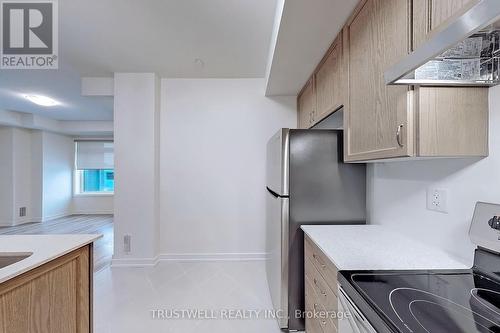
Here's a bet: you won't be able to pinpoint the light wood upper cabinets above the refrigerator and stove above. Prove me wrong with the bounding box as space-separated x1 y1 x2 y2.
292 0 488 162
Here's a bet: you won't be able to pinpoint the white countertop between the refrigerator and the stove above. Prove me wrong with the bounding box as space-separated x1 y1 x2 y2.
302 225 470 270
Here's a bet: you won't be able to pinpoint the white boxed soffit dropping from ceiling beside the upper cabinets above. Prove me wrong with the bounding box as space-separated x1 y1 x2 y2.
266 0 359 96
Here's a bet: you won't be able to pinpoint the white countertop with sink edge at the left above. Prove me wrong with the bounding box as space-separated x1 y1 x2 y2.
0 235 102 283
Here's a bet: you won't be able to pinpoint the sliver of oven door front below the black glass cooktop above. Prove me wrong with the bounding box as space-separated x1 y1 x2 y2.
338 286 377 333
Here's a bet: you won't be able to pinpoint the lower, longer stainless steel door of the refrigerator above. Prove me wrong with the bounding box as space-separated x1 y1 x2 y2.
266 190 289 328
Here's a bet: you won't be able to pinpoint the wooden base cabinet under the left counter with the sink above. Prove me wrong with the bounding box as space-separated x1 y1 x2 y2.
0 245 92 333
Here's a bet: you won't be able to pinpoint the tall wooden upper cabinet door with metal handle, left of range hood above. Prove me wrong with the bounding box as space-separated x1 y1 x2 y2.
344 0 413 161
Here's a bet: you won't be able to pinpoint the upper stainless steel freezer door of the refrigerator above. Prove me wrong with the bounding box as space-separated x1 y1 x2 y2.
266 128 289 196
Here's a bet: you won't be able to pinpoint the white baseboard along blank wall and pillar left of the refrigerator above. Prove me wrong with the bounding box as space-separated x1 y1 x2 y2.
111 253 266 267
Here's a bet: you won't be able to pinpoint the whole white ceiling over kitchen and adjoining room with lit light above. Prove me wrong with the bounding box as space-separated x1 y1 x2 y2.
0 0 276 120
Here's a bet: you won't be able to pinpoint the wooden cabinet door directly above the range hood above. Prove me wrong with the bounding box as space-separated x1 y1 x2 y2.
413 0 479 48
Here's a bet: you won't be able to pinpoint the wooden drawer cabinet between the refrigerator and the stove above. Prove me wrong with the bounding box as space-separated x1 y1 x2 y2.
304 236 339 333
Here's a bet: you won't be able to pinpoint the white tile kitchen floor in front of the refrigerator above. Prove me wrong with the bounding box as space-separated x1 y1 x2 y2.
94 261 280 333
